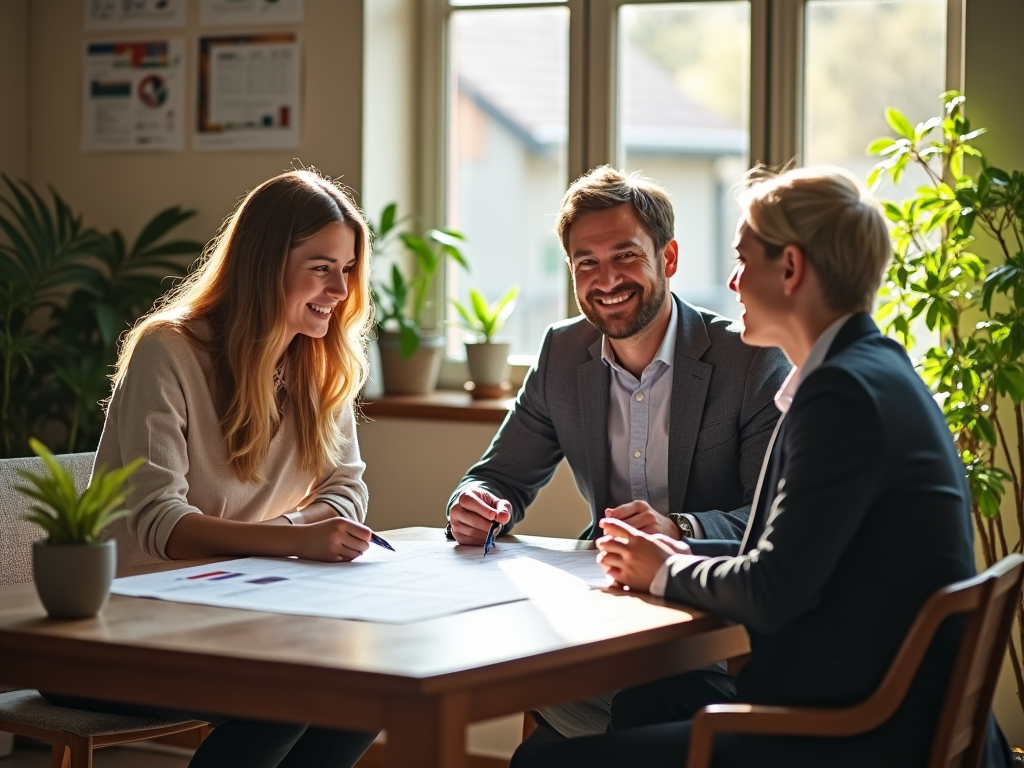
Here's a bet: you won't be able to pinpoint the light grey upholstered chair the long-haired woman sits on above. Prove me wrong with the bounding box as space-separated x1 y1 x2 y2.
0 454 209 768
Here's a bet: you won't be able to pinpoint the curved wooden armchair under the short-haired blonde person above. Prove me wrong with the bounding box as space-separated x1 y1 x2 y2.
686 554 1024 768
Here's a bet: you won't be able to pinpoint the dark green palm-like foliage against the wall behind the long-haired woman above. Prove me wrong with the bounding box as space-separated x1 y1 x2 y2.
0 176 202 457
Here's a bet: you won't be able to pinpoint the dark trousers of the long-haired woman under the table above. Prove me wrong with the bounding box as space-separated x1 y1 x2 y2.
40 691 377 768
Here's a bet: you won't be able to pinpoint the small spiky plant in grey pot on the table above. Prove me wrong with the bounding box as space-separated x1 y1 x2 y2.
16 438 142 618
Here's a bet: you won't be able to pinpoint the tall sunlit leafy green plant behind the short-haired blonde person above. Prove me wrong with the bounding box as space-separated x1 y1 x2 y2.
867 91 1024 709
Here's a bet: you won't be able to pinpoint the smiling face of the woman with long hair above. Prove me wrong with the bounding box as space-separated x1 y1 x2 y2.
285 223 355 341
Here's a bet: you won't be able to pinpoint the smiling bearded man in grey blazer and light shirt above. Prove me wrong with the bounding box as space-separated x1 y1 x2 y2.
447 166 791 738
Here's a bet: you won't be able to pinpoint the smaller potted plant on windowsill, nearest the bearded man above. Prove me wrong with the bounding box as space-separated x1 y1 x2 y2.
452 286 519 399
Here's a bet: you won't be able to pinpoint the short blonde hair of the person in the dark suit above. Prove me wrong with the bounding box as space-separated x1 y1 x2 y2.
738 166 892 311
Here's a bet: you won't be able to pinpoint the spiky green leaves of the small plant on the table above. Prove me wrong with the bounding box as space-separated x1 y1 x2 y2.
14 437 142 544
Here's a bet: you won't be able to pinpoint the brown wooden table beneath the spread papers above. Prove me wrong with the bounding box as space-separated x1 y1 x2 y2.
0 528 749 768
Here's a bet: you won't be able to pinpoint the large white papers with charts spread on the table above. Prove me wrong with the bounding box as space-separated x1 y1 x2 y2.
111 541 607 624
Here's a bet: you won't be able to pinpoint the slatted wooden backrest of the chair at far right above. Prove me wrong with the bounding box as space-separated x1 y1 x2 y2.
929 554 1024 768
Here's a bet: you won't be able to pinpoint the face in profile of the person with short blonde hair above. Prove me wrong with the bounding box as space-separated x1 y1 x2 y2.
729 222 792 347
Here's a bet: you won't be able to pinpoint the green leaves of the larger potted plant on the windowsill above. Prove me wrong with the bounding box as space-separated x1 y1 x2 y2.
368 203 469 358
